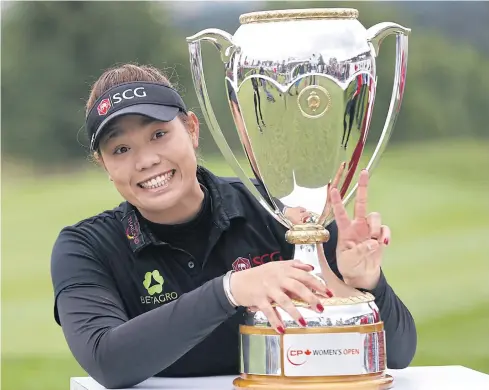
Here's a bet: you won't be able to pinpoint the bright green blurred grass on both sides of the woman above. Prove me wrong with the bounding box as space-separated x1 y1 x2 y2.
1 141 489 390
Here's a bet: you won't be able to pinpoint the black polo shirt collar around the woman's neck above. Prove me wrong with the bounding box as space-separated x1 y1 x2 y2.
121 166 245 253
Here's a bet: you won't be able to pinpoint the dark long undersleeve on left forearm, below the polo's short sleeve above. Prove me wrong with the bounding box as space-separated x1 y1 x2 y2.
57 277 236 388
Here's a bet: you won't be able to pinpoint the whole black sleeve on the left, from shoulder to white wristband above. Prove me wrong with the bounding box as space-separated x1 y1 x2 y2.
51 228 236 388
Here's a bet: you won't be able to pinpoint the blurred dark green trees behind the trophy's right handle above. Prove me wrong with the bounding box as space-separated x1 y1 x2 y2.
266 1 489 142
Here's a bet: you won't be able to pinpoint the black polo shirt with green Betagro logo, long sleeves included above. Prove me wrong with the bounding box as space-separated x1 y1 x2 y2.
51 167 416 387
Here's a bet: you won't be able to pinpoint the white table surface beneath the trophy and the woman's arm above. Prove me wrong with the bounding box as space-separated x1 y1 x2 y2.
70 366 489 390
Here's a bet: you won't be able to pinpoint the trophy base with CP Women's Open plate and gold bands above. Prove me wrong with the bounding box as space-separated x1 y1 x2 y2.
233 294 388 390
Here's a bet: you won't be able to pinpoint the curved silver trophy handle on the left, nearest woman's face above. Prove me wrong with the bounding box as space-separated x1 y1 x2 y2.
187 28 289 227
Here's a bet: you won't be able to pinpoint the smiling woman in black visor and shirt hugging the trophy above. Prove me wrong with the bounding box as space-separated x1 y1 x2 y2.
51 65 416 388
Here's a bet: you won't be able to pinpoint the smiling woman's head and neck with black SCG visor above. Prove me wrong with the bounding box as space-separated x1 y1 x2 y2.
87 65 203 224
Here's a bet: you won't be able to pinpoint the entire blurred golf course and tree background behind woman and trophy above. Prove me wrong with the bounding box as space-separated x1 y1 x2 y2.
1 1 489 390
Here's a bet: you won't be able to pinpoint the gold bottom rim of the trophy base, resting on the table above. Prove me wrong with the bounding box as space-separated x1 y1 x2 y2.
233 374 394 390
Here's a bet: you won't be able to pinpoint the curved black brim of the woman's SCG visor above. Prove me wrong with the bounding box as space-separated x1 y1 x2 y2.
92 104 180 149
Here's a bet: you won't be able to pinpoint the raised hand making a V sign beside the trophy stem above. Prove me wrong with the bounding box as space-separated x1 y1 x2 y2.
331 170 391 290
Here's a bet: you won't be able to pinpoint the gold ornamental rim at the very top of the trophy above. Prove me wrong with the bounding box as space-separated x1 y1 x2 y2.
239 8 358 24
